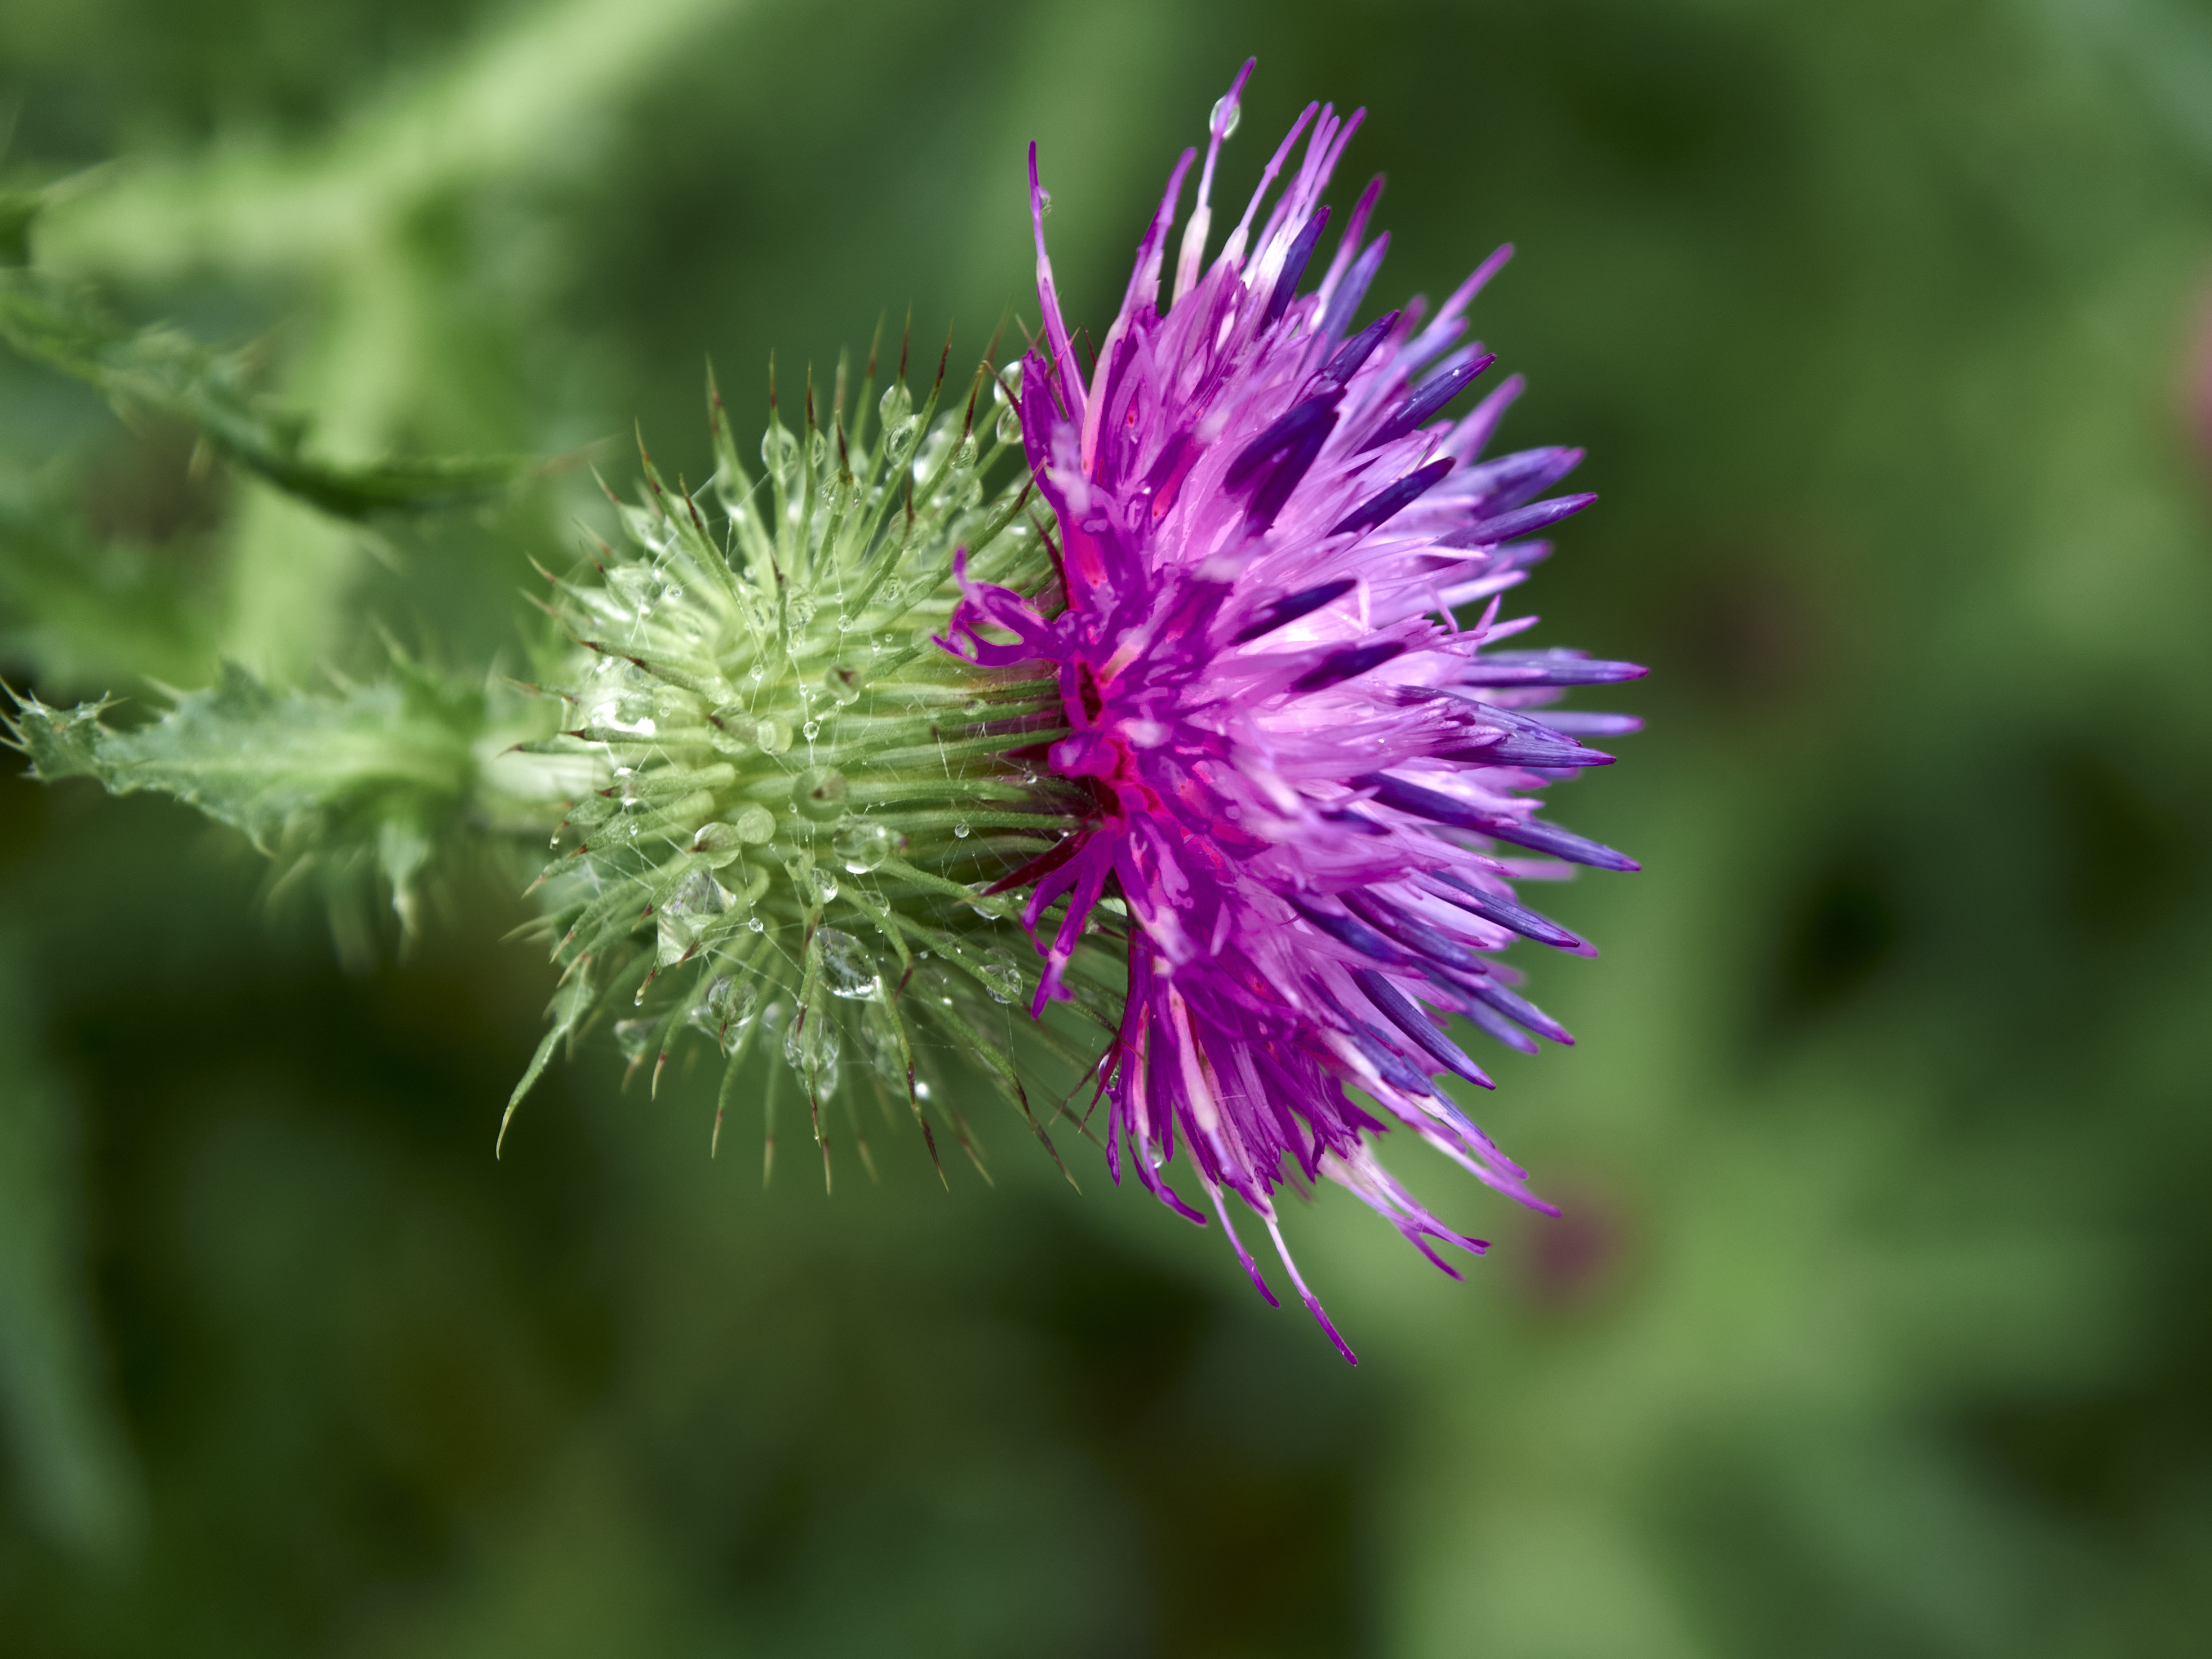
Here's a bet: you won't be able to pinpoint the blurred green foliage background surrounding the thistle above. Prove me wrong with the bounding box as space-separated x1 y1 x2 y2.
0 0 2212 1659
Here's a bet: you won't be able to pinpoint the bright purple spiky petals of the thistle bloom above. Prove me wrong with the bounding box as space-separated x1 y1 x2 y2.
947 64 1643 1360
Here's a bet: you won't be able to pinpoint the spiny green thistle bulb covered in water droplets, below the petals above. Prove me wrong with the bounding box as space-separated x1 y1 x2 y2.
502 345 1117 1181
